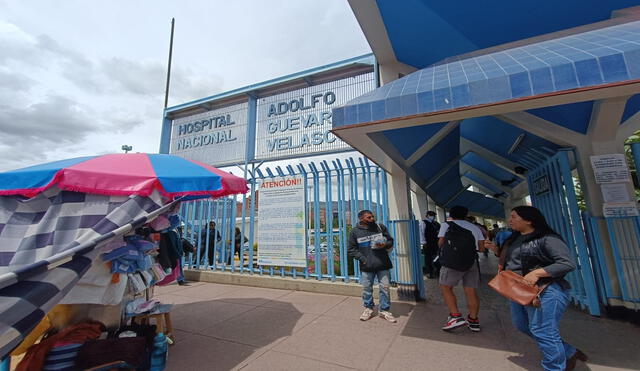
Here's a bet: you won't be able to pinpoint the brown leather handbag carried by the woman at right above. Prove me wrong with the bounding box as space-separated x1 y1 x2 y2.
489 270 548 307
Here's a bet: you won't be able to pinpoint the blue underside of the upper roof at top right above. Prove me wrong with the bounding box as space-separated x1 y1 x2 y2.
376 0 638 68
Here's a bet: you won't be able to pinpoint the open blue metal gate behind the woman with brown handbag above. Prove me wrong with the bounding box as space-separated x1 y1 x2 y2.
527 150 600 315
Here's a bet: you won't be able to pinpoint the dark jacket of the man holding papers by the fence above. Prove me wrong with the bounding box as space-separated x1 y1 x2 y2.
348 224 393 272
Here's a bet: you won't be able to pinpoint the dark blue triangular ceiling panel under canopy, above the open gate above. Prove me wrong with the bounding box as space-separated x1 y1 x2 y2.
527 101 593 134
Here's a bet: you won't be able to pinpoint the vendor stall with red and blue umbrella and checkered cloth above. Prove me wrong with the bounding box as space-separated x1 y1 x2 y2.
0 154 247 370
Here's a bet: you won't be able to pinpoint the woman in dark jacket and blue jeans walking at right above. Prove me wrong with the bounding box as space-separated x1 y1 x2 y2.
486 206 587 370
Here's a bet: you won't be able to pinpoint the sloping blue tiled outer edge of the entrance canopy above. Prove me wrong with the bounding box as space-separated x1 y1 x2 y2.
333 21 640 128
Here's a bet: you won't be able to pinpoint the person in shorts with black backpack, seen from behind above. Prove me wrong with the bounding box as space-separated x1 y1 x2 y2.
438 205 484 332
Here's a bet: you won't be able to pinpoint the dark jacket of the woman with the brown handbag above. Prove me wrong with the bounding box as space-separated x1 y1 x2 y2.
500 233 576 289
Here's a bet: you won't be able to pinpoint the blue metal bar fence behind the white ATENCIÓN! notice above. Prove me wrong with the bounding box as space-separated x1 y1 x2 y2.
181 158 415 284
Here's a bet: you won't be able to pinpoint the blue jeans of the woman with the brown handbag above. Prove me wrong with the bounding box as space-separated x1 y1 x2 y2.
510 283 576 370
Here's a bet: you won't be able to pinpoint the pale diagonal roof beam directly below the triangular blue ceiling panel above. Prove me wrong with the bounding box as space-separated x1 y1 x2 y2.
494 111 585 147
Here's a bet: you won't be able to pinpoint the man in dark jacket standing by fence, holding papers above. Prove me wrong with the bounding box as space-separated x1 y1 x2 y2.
349 210 396 322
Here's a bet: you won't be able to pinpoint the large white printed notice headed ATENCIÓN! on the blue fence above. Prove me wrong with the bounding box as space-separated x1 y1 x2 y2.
258 177 307 267
